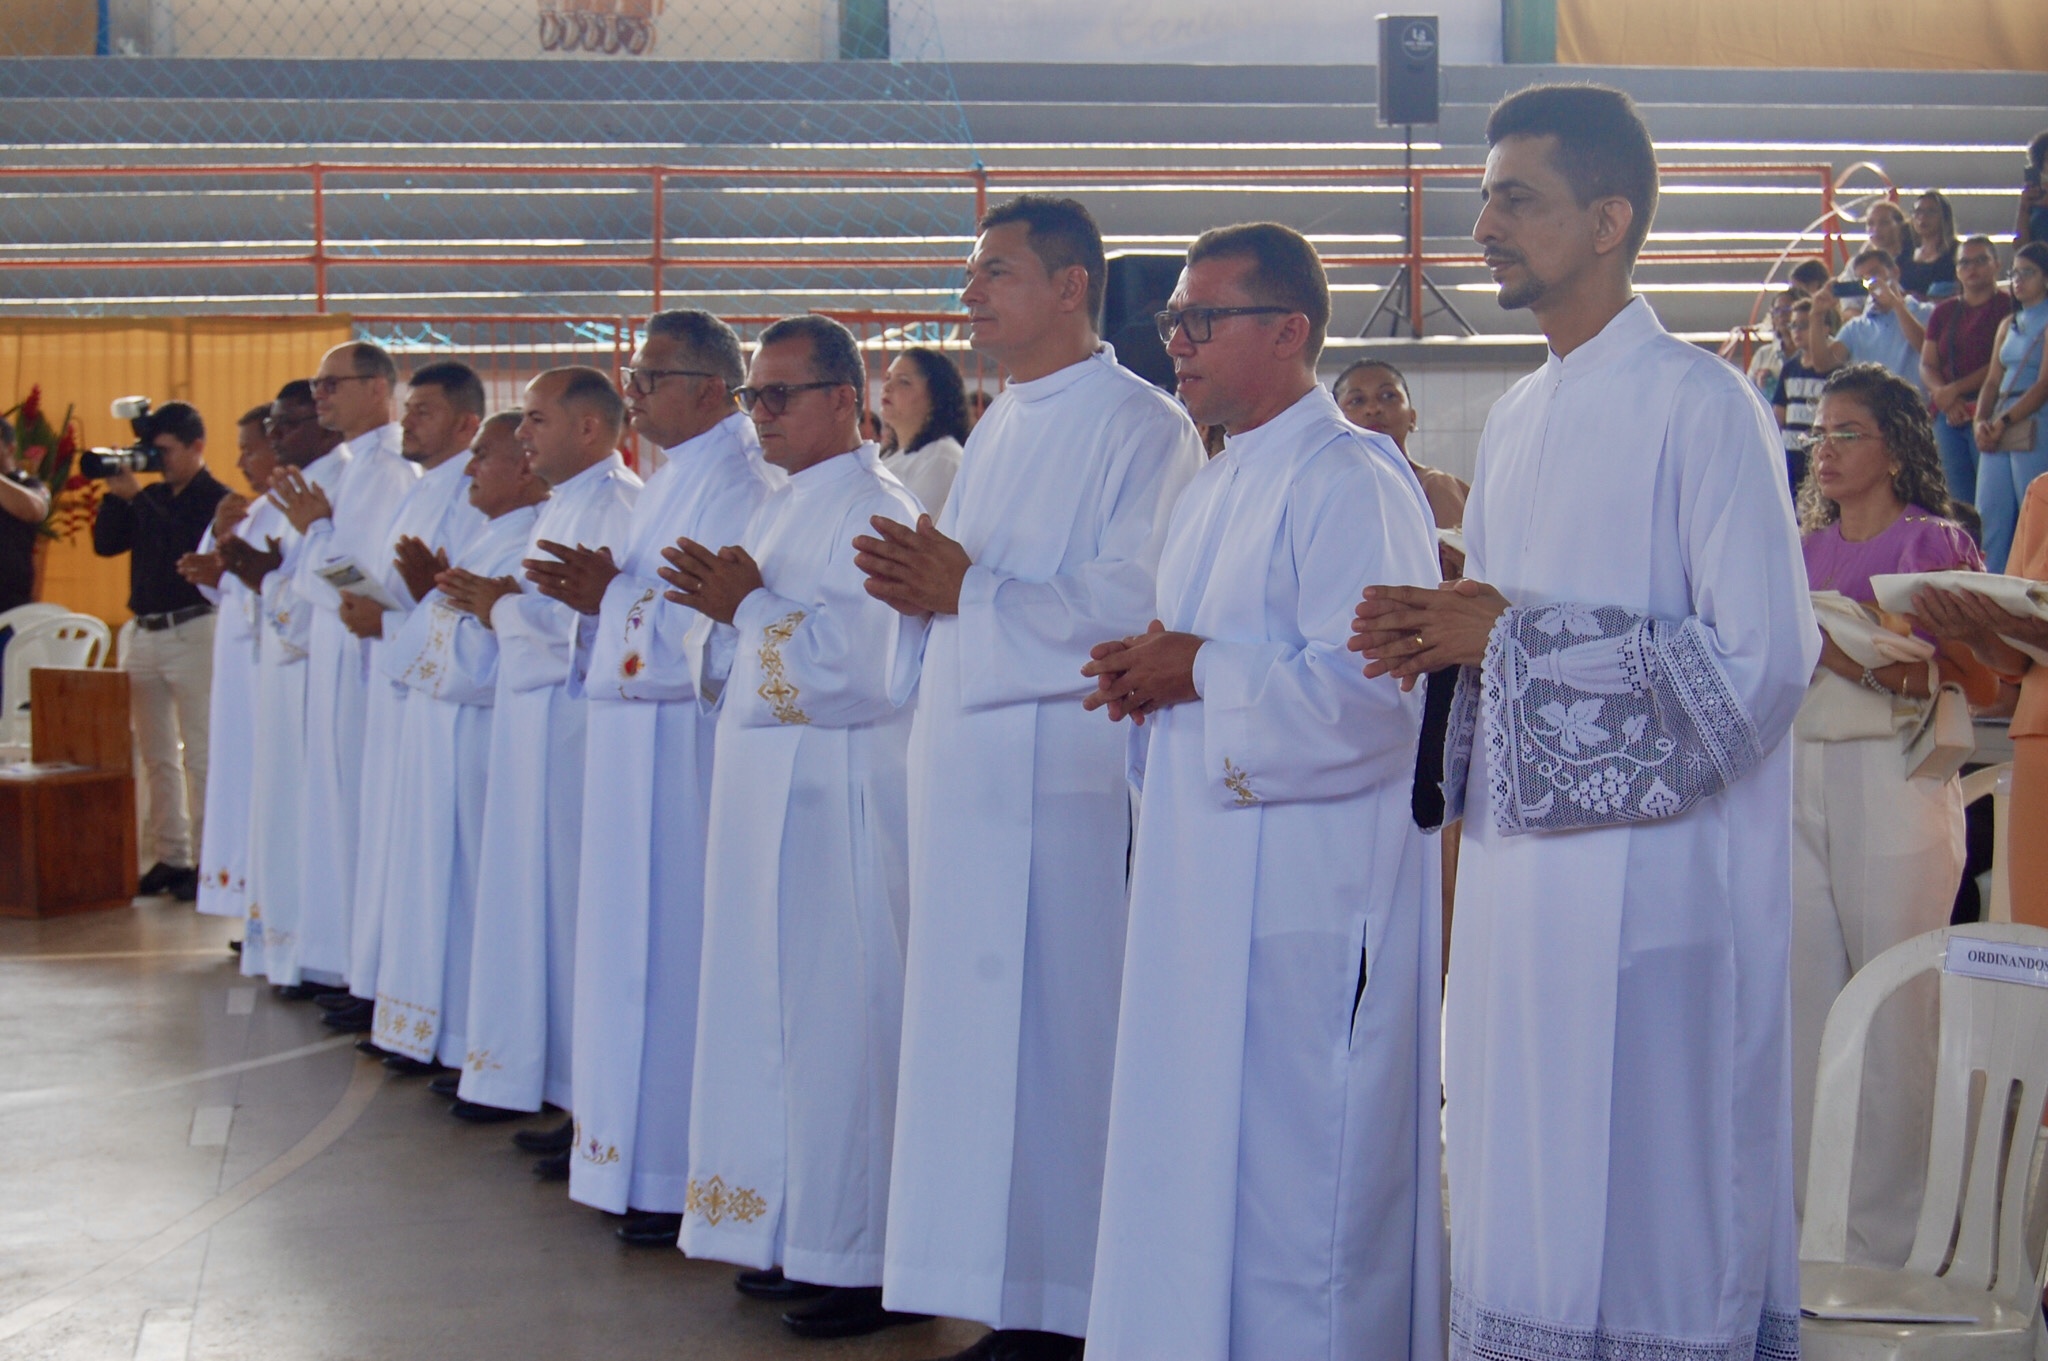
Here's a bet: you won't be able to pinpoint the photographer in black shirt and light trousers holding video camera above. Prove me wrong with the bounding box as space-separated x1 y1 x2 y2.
92 401 227 903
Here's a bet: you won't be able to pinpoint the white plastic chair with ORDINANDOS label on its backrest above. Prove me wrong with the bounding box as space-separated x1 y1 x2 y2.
1798 923 2048 1361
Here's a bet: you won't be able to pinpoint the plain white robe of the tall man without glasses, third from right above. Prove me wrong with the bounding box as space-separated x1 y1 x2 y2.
883 346 1202 1334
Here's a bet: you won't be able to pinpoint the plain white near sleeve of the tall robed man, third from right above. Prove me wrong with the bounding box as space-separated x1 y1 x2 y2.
958 403 1202 708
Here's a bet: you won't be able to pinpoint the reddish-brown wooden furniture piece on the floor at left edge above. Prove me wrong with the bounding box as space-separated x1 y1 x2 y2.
0 667 135 917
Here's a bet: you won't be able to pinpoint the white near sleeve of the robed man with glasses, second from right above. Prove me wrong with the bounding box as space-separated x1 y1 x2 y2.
1194 450 1438 806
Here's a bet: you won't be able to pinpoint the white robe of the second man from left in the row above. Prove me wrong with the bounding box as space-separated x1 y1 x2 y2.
242 446 350 986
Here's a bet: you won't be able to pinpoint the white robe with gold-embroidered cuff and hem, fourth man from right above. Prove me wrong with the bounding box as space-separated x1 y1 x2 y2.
682 444 924 1285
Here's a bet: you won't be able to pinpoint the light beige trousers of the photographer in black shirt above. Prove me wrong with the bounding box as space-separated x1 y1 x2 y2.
121 614 213 868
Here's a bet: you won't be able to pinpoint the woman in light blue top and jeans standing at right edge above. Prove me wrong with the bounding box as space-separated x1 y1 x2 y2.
1976 242 2048 571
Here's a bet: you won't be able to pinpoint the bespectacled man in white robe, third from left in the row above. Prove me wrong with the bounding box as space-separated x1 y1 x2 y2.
270 340 420 982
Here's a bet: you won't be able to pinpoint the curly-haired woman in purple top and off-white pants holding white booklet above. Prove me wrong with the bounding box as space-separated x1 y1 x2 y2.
1792 364 1997 1265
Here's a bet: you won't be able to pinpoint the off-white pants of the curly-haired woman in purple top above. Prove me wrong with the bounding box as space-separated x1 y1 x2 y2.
1792 737 1962 1267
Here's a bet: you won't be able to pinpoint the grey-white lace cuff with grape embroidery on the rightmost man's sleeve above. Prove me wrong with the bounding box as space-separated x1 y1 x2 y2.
1452 604 1763 835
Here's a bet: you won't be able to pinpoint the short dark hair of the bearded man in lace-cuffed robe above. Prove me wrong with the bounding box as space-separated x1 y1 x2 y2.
1487 84 1657 260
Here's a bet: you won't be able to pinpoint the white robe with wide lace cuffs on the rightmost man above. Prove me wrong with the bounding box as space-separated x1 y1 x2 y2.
1444 299 1819 1361
